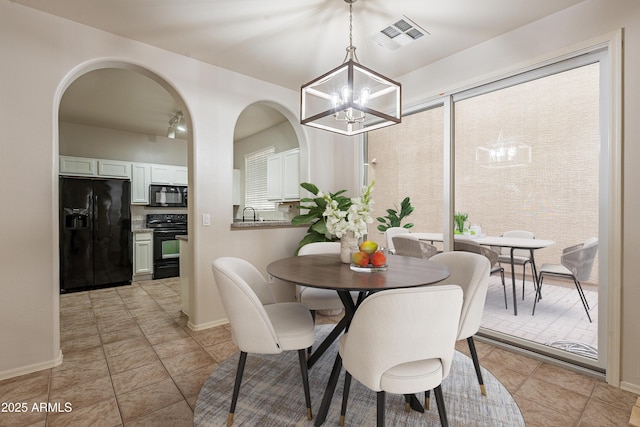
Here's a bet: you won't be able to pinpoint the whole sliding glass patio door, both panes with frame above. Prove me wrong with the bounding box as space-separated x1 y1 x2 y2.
363 50 611 369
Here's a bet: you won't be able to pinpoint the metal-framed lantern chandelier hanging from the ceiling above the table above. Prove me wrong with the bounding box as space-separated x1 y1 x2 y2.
300 0 402 136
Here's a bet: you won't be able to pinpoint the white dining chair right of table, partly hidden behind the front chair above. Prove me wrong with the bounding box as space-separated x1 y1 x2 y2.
425 251 491 402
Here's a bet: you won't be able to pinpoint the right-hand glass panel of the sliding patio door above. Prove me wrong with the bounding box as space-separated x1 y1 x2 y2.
454 55 606 365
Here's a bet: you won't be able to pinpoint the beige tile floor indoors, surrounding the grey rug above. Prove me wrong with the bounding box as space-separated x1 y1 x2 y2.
0 279 637 427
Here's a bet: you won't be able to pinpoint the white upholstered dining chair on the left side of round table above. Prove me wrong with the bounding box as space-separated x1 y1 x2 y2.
213 257 315 426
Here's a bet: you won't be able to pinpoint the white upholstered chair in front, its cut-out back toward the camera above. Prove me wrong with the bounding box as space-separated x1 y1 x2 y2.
338 285 462 426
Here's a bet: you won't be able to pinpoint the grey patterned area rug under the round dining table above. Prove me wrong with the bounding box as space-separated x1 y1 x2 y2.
194 325 525 427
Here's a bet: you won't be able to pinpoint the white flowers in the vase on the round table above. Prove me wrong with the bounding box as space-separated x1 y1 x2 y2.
318 182 374 238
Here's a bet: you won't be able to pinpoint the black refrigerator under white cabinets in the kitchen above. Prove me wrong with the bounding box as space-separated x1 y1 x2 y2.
60 177 133 293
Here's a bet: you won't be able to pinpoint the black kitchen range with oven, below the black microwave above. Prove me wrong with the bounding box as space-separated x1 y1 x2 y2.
147 214 187 279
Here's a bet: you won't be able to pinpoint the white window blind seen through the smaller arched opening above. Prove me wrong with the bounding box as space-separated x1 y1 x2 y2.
244 146 275 211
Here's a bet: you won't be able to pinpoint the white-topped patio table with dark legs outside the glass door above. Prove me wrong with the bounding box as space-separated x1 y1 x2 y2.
411 233 556 316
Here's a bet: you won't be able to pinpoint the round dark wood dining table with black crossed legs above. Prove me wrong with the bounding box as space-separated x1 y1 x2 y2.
267 254 450 426
